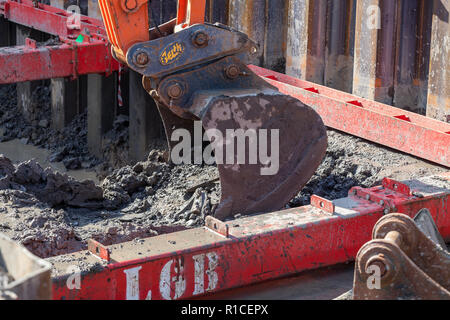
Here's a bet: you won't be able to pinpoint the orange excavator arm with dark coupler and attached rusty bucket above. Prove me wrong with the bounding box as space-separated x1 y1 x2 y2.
99 0 327 219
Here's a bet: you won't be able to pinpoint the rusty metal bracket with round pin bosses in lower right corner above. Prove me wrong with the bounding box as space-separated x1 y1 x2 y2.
353 213 450 300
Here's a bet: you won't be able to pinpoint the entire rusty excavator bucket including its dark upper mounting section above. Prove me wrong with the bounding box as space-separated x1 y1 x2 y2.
149 58 327 219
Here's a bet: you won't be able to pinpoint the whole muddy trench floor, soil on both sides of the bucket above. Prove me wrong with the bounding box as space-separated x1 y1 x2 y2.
0 86 446 258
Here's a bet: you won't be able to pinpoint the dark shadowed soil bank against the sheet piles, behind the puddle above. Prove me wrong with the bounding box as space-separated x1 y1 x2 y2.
0 85 129 178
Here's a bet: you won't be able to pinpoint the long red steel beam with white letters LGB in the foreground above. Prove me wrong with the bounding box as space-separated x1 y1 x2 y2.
48 173 450 300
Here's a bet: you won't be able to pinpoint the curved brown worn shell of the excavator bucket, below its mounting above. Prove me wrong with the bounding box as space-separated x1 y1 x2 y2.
202 94 327 219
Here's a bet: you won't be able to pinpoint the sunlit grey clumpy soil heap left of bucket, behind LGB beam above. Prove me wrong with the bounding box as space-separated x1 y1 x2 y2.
0 151 220 257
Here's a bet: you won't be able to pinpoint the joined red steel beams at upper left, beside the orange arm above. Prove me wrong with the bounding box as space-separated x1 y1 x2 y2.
0 0 119 84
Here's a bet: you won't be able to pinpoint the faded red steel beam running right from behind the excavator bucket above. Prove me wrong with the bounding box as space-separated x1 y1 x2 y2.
249 66 450 167
